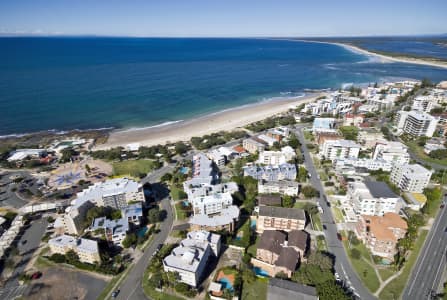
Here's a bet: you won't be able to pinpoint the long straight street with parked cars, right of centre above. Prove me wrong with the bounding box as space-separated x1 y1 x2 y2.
295 127 376 300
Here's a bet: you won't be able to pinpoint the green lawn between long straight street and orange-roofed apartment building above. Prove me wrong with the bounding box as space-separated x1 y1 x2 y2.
343 241 381 292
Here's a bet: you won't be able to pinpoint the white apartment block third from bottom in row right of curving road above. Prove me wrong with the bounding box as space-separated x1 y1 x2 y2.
189 192 233 215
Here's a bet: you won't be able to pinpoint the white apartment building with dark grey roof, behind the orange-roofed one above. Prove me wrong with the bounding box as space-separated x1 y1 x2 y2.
348 181 400 216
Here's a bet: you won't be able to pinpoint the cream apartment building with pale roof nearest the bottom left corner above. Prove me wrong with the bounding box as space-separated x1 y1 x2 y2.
48 235 101 264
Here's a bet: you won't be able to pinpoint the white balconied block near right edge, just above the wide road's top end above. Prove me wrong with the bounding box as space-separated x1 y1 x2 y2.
390 164 432 193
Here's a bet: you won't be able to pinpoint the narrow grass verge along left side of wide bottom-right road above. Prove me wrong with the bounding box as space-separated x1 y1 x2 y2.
379 230 428 300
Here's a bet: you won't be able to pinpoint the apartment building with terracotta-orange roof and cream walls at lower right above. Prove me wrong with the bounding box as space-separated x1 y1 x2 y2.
356 213 408 262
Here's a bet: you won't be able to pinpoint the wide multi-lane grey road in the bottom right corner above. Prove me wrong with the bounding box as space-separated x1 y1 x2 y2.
402 198 447 300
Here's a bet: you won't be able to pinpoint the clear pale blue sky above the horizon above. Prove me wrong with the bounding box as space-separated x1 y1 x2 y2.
0 0 447 37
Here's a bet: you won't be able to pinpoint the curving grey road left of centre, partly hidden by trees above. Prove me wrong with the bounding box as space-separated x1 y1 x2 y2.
116 165 174 300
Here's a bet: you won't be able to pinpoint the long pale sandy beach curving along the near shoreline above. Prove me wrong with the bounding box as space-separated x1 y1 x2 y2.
94 93 327 150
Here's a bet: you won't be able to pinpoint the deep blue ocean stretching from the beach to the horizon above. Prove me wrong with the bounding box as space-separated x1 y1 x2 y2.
0 38 447 135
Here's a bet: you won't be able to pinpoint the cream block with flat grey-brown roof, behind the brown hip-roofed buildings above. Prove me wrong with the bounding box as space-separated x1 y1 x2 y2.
256 206 306 233
